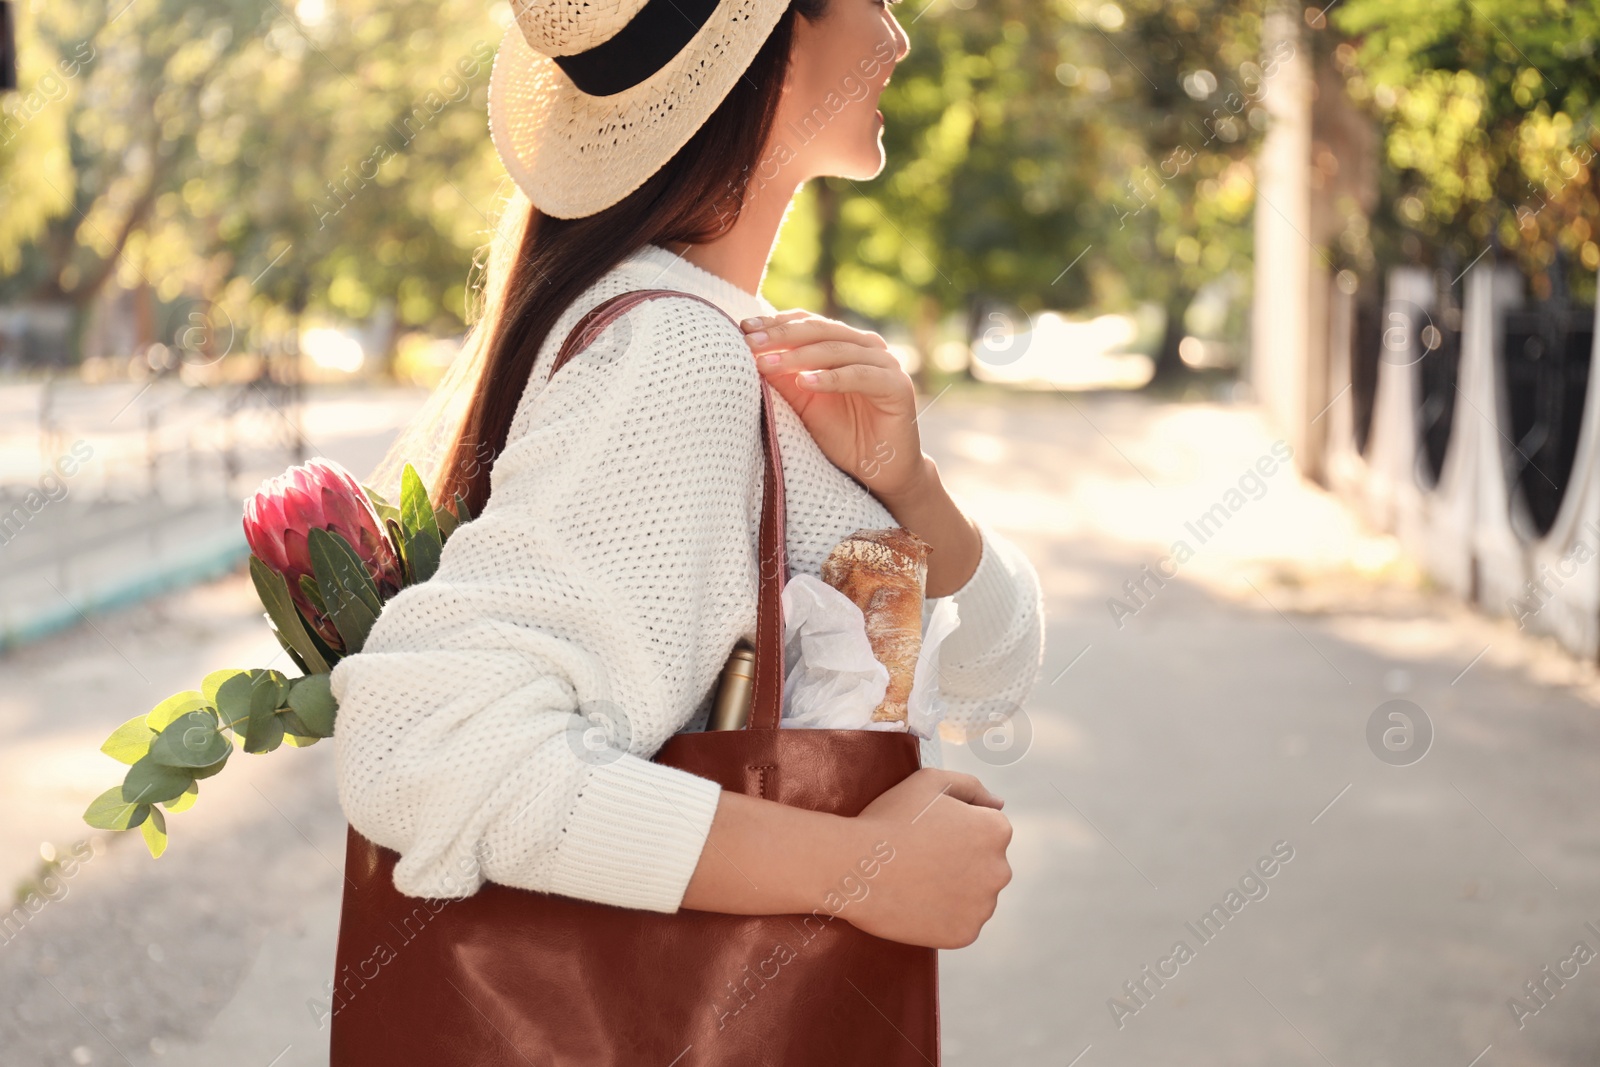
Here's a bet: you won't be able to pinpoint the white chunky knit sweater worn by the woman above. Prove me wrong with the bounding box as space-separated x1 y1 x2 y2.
333 245 1043 912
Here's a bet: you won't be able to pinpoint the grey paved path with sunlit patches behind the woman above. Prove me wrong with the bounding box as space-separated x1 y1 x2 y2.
0 392 1600 1067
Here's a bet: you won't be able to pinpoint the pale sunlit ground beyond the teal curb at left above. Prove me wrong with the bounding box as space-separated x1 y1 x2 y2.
0 382 422 653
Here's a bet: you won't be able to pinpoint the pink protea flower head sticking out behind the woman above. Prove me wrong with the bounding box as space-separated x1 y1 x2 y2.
245 459 403 646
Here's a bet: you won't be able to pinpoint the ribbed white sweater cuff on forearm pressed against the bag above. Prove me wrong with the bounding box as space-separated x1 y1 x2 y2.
549 753 722 912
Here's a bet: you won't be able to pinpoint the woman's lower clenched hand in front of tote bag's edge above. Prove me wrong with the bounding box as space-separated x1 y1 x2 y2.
840 768 1011 949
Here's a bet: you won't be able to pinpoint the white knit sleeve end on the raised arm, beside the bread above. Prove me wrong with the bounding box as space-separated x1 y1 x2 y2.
939 520 1045 737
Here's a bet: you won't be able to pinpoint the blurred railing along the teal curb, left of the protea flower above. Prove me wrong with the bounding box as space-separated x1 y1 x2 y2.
0 355 307 651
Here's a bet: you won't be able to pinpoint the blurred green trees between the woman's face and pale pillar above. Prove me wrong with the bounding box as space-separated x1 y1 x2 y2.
819 0 1274 388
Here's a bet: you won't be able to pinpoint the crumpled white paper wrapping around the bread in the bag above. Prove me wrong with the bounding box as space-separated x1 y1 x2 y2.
781 574 960 737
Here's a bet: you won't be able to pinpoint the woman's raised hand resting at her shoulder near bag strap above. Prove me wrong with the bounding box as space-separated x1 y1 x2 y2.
741 310 931 510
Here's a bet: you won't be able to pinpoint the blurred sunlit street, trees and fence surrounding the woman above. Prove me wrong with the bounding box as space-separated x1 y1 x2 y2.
0 0 1600 1067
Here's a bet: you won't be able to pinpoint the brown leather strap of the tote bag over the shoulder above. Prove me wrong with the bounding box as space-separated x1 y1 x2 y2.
546 290 789 729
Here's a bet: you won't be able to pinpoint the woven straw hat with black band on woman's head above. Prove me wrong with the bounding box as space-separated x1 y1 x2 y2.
490 0 790 219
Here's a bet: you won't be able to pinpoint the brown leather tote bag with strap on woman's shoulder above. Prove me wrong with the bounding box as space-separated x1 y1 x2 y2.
331 290 939 1067
